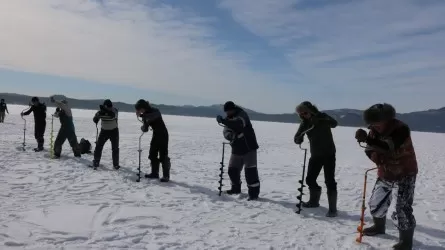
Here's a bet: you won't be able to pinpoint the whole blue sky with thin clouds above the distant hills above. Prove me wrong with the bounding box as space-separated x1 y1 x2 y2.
0 0 445 113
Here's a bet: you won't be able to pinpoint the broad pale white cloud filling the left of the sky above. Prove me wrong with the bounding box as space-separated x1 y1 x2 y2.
0 0 302 112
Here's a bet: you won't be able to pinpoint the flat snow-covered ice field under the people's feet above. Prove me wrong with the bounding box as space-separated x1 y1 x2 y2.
0 105 445 250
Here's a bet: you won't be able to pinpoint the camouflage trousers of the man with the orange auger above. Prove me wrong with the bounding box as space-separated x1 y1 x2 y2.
369 176 416 231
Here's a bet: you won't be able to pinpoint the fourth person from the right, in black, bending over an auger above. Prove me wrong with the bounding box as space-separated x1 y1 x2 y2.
135 99 171 182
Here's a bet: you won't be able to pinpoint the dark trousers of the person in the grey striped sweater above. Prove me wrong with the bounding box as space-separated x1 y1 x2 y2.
94 128 119 166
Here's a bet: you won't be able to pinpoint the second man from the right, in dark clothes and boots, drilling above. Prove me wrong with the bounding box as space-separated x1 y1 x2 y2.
294 101 338 217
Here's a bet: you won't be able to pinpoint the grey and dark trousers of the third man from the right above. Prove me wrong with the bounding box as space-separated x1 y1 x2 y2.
228 150 260 197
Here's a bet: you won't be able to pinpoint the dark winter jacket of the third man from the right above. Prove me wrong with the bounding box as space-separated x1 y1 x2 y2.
222 108 259 155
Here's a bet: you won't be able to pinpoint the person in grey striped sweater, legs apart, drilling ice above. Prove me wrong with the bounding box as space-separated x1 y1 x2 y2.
93 99 119 170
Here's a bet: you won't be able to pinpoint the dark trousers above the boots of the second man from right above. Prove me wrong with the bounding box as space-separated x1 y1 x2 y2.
306 154 337 191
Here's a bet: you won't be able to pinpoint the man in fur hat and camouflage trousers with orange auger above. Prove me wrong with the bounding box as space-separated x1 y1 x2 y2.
355 103 418 249
